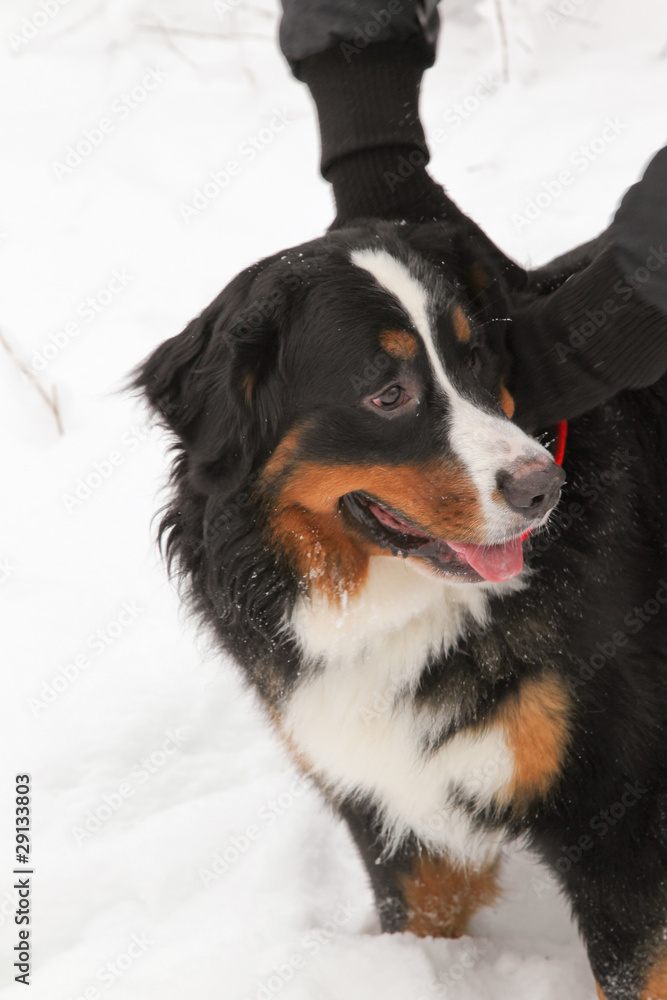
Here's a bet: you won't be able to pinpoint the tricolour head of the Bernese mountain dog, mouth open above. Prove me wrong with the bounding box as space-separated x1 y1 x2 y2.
137 224 563 593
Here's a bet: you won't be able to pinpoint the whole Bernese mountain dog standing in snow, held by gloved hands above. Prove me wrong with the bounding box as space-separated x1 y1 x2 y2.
136 219 667 1000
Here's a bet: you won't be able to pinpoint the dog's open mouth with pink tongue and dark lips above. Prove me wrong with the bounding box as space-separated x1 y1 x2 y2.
341 492 523 583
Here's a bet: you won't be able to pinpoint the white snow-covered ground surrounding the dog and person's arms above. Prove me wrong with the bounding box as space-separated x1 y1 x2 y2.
0 0 667 1000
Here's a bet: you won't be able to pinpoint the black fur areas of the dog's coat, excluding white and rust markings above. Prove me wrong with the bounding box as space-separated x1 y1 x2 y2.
136 221 667 1000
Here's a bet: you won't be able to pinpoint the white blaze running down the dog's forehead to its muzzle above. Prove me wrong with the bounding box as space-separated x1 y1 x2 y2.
351 249 551 542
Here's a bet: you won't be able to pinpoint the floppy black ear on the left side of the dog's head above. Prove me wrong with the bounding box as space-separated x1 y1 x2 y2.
133 258 298 493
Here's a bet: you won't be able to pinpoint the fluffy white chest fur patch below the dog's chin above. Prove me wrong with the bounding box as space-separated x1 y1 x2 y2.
283 557 512 865
